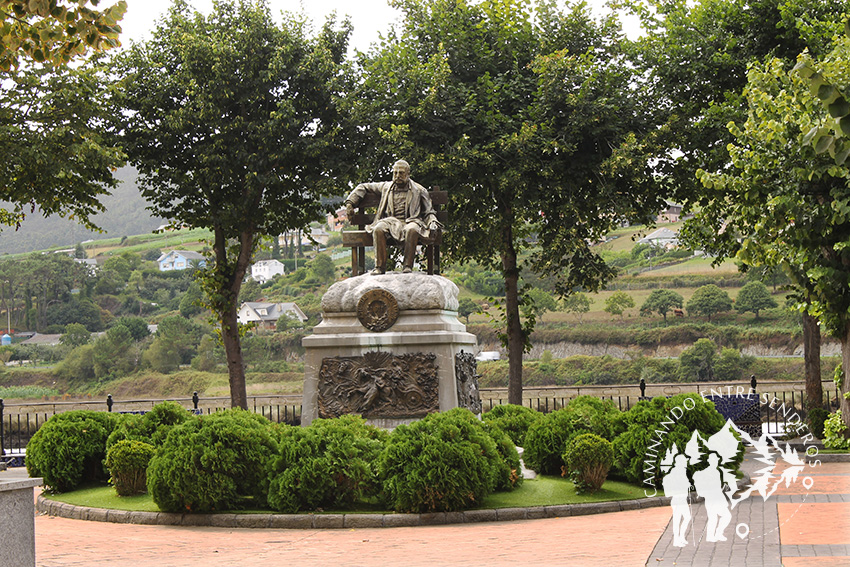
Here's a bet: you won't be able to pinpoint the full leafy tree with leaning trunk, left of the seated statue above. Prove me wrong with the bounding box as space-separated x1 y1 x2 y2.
120 0 350 408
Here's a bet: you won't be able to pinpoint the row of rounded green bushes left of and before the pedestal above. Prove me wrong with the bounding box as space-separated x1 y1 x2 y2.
27 402 522 513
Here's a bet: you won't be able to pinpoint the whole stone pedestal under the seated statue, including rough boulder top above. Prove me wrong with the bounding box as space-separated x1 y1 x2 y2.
301 273 480 428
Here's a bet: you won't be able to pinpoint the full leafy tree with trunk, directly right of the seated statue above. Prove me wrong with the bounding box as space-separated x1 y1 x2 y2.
354 0 662 404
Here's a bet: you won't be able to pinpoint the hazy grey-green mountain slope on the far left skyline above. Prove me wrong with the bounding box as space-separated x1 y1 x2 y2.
0 167 164 254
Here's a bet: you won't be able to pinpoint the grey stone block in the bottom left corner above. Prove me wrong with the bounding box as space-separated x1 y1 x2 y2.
0 478 41 567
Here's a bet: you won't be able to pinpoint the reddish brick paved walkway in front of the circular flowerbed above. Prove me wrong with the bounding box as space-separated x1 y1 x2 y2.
0 463 850 567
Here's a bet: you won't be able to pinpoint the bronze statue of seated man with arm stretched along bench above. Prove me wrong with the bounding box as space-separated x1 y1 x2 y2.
345 160 443 274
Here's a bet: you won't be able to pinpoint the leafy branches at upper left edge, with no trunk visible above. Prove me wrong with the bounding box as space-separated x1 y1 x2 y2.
0 18 126 229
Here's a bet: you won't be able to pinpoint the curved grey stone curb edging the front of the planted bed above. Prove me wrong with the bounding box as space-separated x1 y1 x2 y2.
36 494 670 530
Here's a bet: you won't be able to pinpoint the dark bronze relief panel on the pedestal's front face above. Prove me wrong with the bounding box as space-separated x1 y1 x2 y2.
319 352 440 418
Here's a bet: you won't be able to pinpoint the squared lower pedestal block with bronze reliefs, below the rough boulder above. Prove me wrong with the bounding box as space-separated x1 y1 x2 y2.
301 310 480 429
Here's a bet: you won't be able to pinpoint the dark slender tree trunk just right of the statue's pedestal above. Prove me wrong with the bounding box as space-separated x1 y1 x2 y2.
502 222 525 406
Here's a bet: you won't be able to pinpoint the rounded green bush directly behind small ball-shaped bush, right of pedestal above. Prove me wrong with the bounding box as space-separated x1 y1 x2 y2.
523 396 620 475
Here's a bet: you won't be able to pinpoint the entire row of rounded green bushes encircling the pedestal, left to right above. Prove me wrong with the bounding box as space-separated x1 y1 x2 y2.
27 394 728 513
